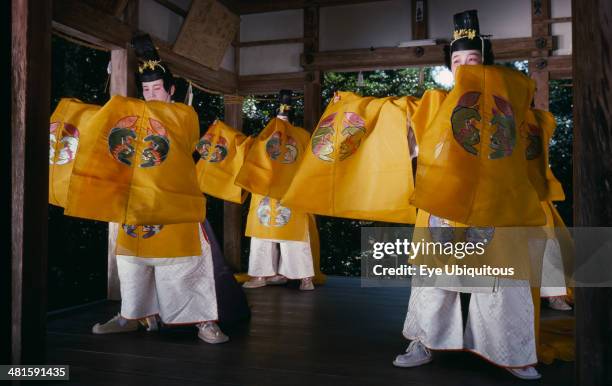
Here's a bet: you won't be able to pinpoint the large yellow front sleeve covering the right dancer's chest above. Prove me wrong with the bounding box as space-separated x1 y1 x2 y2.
411 65 545 226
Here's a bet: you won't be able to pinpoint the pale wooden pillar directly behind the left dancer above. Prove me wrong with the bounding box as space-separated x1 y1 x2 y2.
106 0 138 300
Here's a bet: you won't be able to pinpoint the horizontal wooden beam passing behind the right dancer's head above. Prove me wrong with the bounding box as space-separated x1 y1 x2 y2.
301 36 553 71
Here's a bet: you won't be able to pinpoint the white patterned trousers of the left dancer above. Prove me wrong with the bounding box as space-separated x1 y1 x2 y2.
117 229 218 324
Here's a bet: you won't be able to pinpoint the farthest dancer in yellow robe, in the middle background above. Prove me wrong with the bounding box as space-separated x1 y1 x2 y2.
235 90 319 290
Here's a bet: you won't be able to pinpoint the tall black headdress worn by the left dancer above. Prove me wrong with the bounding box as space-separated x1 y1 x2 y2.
132 34 174 92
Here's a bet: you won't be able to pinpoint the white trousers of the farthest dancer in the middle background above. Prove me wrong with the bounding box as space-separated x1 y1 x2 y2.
248 237 314 279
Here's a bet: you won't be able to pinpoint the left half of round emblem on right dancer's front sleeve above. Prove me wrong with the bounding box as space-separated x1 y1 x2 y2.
451 91 482 155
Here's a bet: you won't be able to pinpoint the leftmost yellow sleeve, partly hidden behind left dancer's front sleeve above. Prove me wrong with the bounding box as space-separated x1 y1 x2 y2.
49 98 100 208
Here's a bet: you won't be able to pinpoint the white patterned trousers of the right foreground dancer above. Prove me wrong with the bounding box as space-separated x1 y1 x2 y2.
403 279 537 367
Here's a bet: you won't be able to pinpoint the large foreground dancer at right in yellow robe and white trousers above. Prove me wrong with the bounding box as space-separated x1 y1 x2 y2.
393 10 545 380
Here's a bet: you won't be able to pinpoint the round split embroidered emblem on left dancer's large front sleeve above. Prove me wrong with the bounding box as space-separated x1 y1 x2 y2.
108 116 170 168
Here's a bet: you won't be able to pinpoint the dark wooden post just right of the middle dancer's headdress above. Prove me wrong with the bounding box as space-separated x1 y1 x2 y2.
304 6 323 131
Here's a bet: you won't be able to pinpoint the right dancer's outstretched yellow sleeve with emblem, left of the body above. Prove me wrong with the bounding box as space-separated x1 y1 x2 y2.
281 92 417 223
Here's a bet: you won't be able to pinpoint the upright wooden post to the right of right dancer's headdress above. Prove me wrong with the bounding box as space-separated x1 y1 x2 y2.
529 0 550 111
